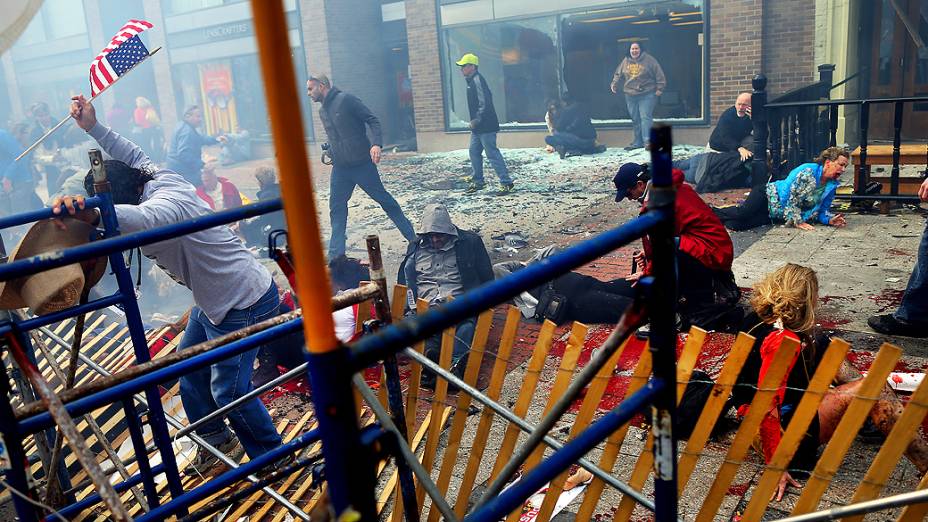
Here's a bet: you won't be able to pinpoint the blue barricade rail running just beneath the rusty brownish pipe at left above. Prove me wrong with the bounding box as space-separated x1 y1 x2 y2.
19 319 302 433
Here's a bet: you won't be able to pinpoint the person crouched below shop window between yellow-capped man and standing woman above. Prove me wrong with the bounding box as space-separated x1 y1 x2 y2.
545 94 606 159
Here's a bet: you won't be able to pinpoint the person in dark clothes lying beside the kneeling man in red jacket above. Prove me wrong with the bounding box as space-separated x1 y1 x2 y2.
493 245 635 324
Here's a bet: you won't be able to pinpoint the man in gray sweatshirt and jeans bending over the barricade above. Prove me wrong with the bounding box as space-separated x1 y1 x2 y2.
52 96 281 475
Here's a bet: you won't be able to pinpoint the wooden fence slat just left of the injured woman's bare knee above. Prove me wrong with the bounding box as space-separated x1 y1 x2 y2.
744 339 848 520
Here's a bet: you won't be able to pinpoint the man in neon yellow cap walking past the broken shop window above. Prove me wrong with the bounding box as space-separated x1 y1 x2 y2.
457 53 513 196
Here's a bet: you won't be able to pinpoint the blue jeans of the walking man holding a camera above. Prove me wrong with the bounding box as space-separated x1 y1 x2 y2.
329 162 416 259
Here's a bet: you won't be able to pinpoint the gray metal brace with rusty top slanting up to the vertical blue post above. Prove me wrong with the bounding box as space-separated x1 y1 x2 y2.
477 296 647 508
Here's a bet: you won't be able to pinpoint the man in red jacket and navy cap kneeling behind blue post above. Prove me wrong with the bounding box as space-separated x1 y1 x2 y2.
612 163 741 329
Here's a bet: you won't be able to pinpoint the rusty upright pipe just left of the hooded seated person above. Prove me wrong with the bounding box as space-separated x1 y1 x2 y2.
364 235 419 522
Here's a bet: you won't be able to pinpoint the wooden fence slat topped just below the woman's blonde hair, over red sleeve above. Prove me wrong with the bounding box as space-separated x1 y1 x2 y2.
696 338 799 522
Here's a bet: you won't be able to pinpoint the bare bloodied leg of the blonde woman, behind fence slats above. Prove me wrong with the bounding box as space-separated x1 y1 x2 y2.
818 376 928 474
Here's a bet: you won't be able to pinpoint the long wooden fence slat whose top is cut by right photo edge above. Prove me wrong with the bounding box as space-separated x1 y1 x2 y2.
845 358 928 522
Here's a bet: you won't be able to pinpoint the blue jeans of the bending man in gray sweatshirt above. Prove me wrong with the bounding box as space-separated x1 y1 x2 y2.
178 282 281 459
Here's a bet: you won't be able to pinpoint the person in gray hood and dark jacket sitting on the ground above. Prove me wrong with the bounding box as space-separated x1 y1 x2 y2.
397 203 493 389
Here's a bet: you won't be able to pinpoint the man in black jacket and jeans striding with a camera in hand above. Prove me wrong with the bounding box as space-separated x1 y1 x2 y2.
306 75 416 260
